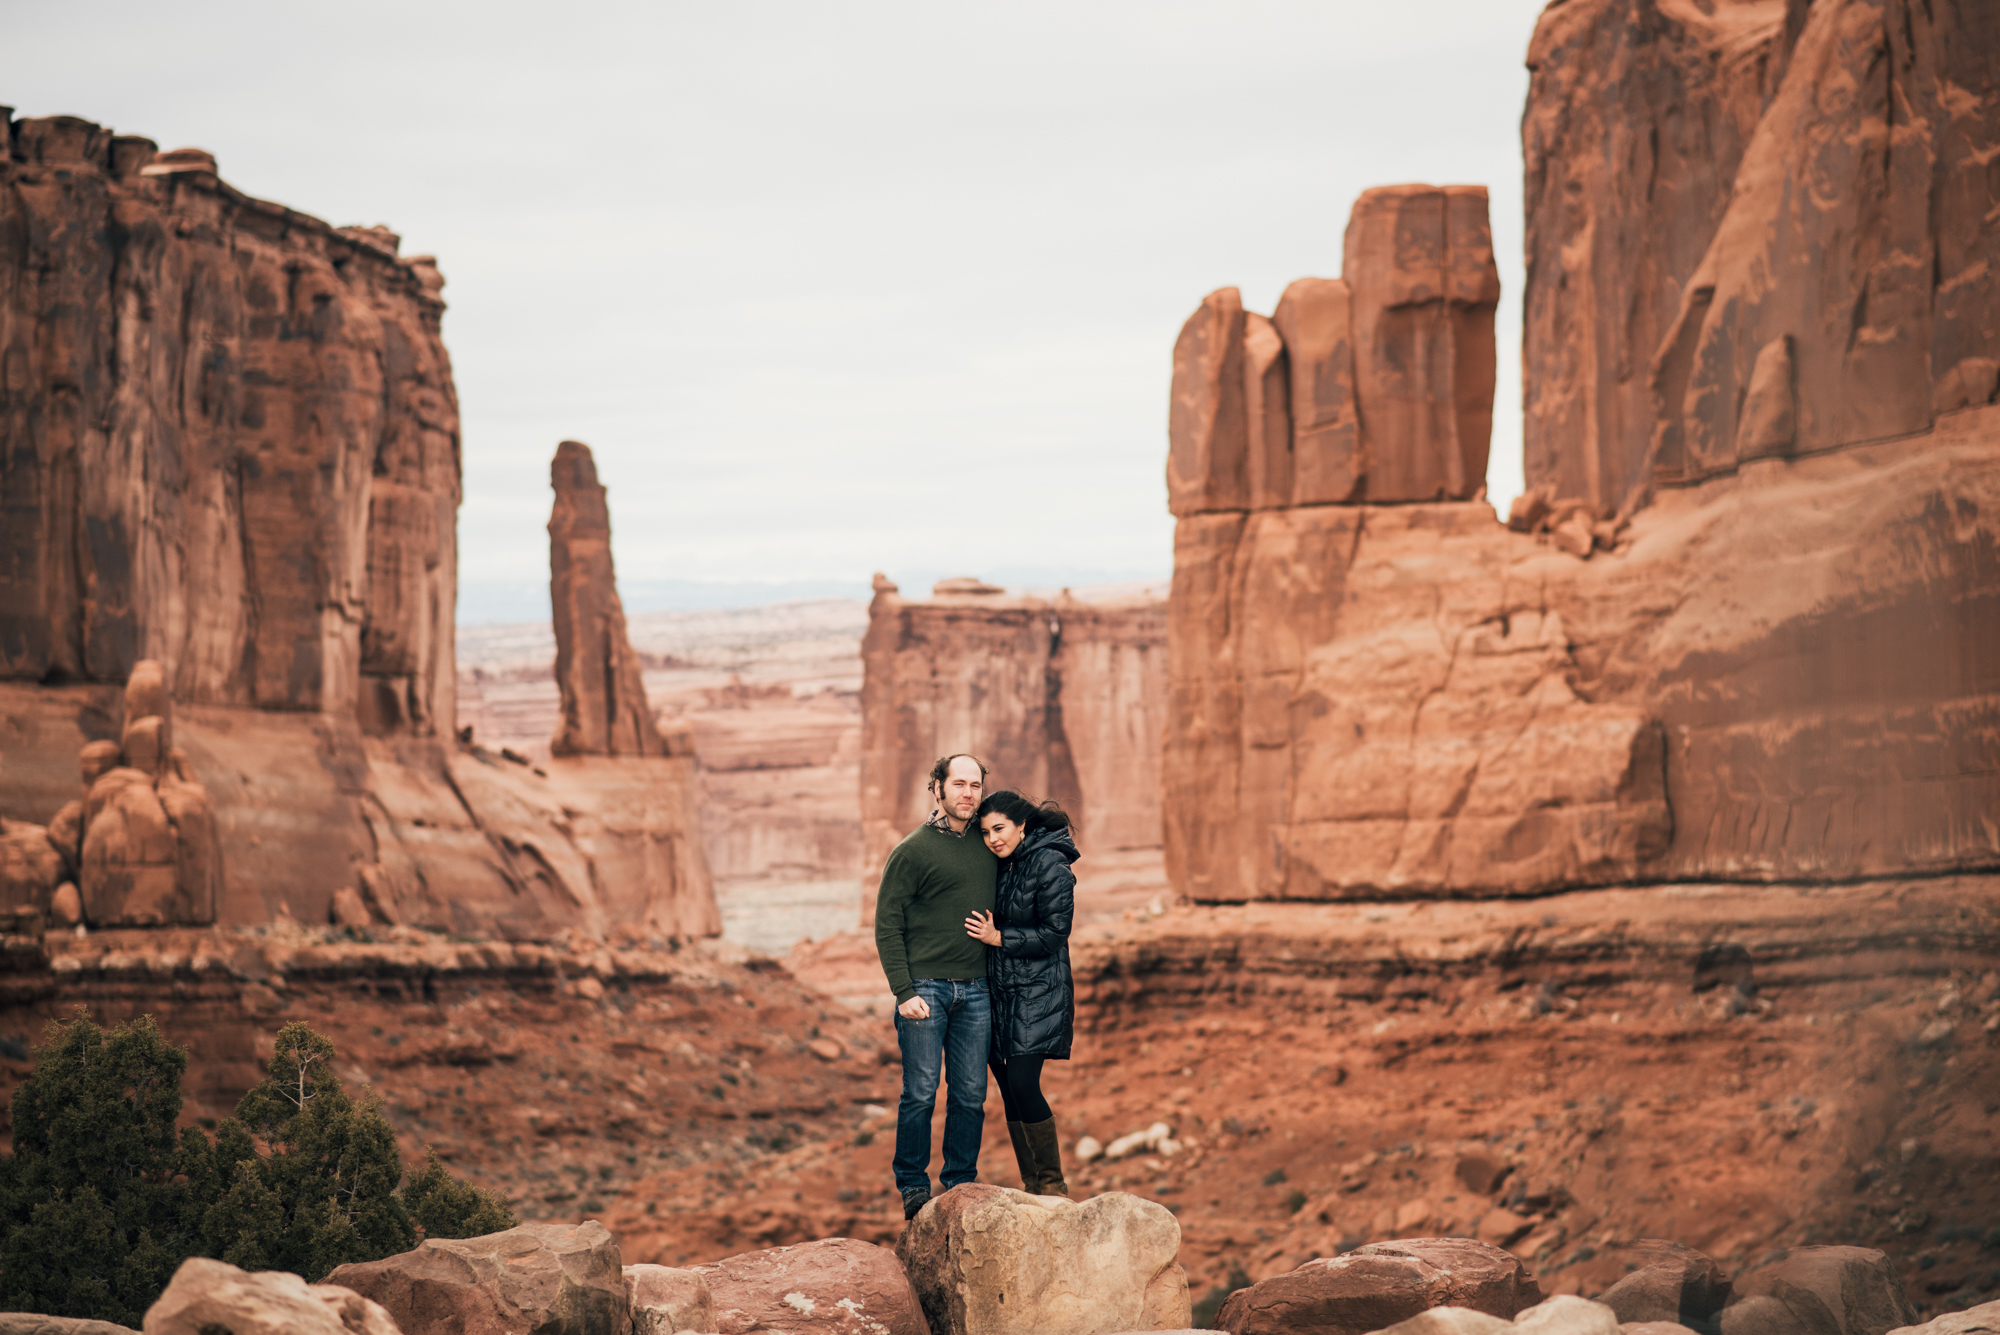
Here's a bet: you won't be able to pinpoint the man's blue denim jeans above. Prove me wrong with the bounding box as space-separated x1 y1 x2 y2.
894 977 992 1191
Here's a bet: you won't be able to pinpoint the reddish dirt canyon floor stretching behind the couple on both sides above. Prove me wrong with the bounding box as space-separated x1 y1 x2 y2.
0 877 2000 1311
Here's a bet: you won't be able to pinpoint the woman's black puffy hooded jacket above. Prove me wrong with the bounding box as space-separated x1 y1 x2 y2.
986 829 1076 1059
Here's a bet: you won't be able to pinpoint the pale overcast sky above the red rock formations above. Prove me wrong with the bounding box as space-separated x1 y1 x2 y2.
0 0 1540 620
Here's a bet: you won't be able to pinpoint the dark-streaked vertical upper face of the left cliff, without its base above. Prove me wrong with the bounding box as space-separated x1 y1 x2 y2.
0 116 458 735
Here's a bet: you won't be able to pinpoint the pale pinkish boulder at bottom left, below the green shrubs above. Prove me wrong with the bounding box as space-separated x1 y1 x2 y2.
142 1257 402 1335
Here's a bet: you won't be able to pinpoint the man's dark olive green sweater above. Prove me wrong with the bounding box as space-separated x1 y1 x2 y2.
876 825 1000 1005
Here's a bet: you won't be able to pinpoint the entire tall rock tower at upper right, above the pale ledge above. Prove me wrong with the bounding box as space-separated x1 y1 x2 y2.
1522 0 2000 514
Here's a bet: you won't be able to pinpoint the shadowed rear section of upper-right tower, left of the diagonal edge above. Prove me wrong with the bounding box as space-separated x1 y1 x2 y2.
1522 0 1806 514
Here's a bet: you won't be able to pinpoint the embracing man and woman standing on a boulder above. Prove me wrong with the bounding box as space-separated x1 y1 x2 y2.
876 753 1076 1219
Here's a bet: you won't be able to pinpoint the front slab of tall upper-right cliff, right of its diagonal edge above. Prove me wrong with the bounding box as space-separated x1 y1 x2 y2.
1652 0 2000 482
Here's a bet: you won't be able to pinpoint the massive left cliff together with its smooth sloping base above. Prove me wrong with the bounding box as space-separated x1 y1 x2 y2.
0 116 720 937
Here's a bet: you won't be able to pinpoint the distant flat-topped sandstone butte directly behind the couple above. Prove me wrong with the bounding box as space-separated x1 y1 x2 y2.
862 576 1166 923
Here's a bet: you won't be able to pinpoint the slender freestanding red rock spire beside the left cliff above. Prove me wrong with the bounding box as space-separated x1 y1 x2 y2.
548 440 666 755
